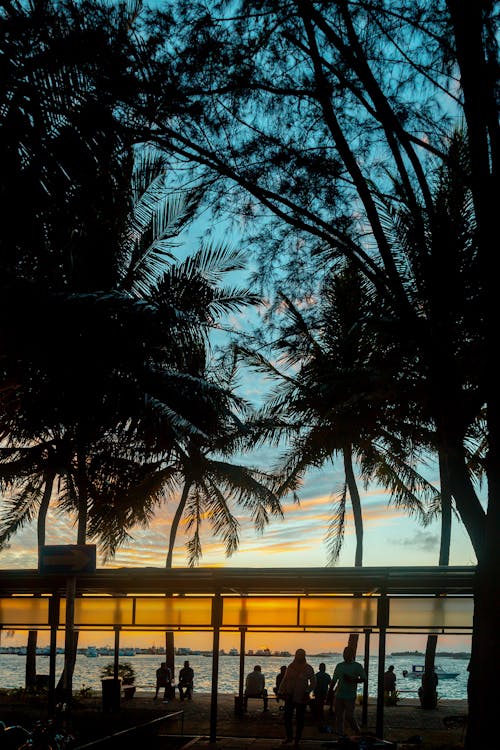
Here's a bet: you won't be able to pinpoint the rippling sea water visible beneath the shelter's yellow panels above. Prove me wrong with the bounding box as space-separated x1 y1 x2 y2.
0 653 468 700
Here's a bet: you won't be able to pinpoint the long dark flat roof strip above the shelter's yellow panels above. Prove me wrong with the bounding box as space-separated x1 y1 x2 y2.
0 566 476 596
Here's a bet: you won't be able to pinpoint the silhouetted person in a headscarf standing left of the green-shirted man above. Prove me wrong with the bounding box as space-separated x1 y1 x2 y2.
278 648 316 747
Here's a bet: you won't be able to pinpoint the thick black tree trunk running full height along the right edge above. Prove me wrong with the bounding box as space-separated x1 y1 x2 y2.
440 8 500 750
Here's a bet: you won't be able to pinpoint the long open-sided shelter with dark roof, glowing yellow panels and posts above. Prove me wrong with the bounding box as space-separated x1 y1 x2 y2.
0 566 475 742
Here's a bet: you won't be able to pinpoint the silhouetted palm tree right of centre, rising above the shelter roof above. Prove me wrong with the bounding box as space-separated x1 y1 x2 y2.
240 267 436 566
